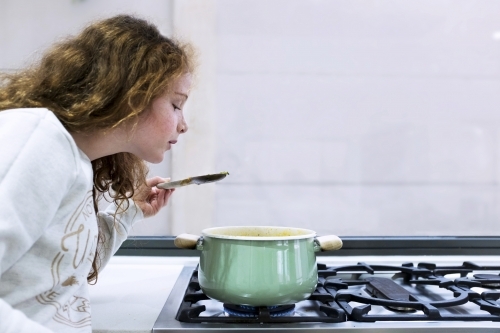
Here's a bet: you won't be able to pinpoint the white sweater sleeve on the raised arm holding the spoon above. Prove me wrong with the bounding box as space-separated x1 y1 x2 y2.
97 199 144 270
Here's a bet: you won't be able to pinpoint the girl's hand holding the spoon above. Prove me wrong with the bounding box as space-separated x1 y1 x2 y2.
132 177 174 217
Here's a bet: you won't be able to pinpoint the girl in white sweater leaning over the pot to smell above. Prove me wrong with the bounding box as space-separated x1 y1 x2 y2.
0 15 193 333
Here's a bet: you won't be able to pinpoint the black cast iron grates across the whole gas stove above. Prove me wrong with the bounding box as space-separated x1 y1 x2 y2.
176 262 500 324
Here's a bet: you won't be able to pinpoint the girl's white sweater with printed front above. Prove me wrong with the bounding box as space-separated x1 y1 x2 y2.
0 108 143 333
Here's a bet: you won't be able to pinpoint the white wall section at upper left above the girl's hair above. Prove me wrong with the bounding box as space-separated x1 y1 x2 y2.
0 0 172 69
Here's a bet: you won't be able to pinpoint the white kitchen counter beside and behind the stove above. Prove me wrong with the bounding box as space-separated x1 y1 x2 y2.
90 256 500 333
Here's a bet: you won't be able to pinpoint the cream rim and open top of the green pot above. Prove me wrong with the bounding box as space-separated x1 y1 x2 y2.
201 226 316 241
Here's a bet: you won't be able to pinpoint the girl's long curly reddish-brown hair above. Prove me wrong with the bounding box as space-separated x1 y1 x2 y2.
0 15 194 283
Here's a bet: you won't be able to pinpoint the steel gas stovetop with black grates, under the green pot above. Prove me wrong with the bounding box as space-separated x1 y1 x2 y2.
153 261 500 332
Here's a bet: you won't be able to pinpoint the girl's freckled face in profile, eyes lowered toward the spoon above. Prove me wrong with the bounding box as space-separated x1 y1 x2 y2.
129 74 191 163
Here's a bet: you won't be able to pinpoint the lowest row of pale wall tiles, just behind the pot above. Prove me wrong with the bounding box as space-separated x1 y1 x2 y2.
217 184 499 235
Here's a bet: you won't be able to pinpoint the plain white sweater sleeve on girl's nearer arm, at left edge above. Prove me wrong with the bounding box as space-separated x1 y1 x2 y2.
0 109 75 333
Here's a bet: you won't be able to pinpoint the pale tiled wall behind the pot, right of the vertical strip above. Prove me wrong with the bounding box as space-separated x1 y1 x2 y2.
215 0 500 235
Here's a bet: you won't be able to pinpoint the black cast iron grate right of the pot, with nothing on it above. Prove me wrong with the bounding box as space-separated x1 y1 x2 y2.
318 262 500 322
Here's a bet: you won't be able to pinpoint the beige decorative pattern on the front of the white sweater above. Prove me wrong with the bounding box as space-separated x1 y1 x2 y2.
36 191 97 328
